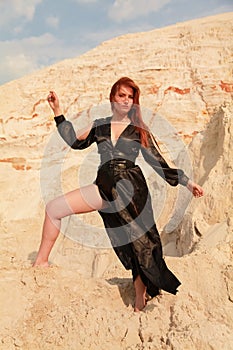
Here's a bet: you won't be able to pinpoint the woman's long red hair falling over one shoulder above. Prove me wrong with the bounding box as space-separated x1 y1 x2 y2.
109 77 148 147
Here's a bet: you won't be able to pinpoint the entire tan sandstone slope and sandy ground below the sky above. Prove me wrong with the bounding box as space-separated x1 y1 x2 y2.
0 13 233 350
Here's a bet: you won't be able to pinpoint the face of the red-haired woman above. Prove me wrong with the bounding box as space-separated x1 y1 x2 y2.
113 85 133 115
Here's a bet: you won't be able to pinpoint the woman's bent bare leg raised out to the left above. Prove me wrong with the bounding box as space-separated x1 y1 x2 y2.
33 184 104 267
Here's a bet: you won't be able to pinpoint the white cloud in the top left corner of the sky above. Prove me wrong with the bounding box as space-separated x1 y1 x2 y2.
0 0 43 26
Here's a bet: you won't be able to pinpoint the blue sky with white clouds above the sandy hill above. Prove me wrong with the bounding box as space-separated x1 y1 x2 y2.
0 0 233 85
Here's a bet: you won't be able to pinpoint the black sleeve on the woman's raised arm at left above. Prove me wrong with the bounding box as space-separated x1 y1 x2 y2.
54 115 95 149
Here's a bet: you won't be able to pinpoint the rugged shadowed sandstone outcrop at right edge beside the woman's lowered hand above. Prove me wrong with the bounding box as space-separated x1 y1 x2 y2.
164 103 233 255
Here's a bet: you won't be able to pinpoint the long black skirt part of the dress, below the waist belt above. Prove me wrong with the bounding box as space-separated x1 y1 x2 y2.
96 161 180 297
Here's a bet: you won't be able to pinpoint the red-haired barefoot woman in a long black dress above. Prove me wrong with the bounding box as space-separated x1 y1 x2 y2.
34 77 203 311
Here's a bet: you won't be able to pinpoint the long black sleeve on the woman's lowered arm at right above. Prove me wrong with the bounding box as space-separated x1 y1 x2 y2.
141 134 189 186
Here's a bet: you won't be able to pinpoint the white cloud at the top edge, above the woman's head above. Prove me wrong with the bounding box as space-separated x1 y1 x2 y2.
108 0 171 22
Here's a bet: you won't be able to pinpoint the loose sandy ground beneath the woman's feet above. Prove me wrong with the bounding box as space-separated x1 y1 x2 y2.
1 213 233 350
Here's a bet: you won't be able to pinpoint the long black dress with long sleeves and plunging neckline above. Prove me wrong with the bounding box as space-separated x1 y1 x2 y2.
55 115 189 297
